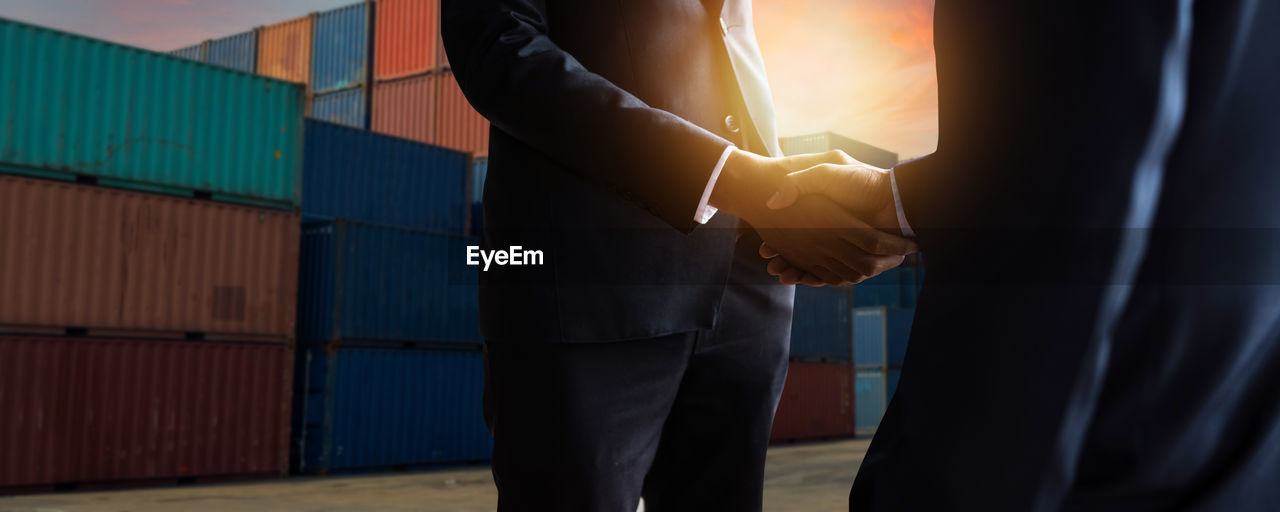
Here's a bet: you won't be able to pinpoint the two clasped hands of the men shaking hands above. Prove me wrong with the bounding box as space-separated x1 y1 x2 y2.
709 150 918 287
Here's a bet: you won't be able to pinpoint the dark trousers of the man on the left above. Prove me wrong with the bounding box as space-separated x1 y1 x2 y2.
485 267 791 512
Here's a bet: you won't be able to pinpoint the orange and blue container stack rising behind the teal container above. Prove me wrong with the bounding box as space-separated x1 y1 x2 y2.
173 0 489 157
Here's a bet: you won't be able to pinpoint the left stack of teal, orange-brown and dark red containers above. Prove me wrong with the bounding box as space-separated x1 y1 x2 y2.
0 19 303 493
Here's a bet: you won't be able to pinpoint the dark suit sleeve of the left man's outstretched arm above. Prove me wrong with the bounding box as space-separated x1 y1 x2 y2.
442 0 731 232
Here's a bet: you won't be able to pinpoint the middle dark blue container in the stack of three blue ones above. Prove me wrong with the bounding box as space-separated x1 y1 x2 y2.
298 220 483 343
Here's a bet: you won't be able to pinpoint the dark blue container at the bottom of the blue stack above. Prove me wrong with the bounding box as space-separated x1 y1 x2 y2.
293 344 493 475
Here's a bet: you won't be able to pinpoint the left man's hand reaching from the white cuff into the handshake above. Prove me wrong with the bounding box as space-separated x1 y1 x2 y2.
710 151 915 285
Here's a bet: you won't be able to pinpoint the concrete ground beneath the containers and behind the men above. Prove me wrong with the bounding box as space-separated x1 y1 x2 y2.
0 439 869 512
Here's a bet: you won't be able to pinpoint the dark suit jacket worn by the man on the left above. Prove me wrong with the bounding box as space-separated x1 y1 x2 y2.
442 0 792 342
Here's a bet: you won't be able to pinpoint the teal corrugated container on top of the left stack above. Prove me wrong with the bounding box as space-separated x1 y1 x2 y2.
0 19 305 206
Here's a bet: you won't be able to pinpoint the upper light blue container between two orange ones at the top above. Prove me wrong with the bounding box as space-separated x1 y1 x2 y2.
311 3 372 92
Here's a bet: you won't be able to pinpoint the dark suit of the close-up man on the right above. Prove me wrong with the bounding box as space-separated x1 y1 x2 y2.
850 0 1280 511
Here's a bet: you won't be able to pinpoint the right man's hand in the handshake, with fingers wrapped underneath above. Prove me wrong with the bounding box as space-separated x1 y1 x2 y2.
760 159 914 285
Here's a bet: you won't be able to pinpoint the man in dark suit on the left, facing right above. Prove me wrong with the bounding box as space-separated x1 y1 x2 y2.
442 0 913 512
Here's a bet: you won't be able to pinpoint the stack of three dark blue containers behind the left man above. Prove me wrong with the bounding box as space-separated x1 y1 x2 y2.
292 120 492 474
